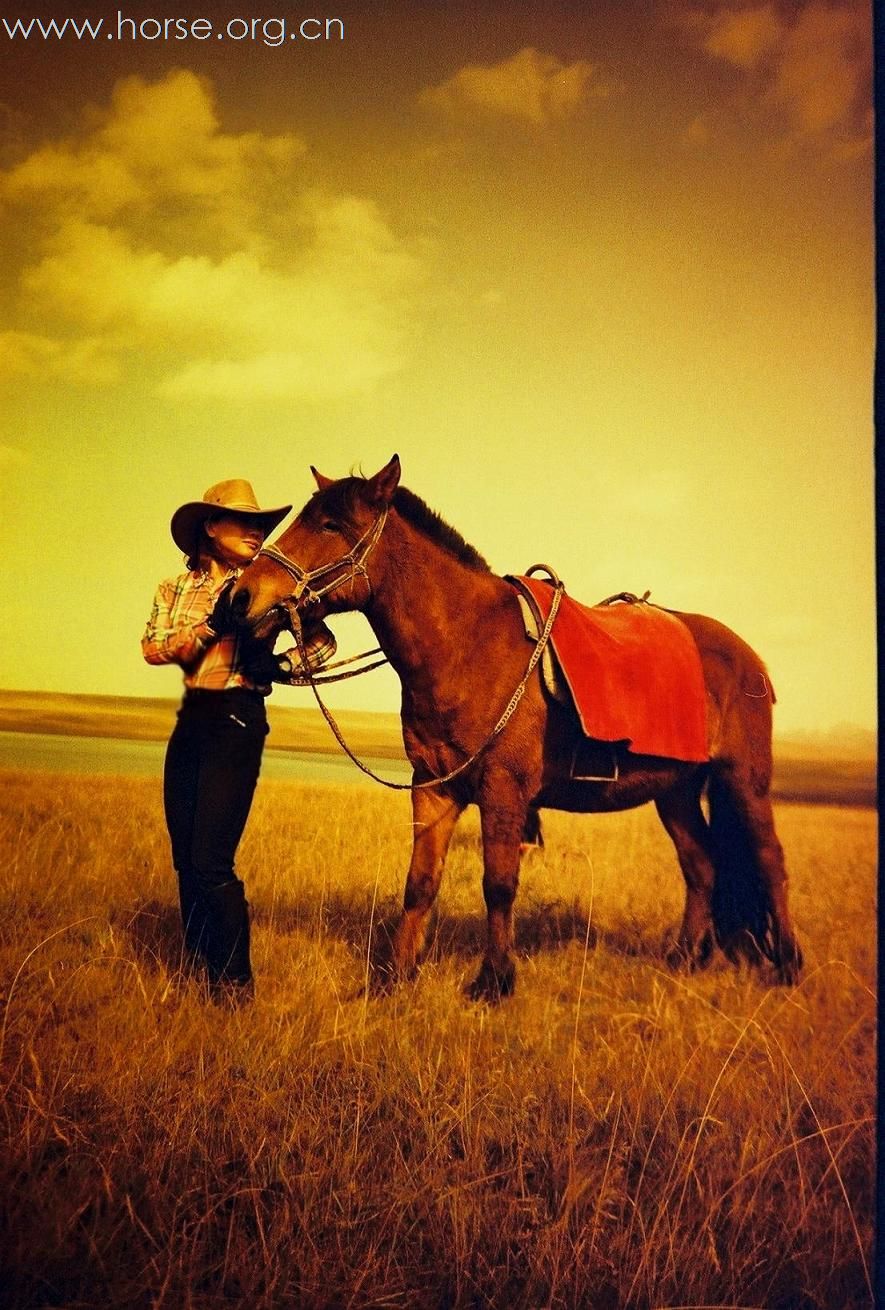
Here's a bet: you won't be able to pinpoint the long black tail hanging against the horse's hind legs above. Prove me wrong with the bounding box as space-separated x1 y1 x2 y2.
707 766 778 964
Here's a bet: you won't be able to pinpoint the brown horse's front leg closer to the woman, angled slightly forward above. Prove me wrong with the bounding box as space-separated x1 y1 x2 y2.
393 787 463 979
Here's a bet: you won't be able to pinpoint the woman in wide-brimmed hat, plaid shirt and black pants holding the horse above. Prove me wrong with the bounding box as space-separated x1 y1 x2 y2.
141 478 335 1000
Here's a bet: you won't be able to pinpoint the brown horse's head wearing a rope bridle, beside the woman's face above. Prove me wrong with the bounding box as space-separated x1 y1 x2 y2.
232 455 401 635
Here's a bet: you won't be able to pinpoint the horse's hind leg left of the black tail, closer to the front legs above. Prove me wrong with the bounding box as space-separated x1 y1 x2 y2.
656 773 715 968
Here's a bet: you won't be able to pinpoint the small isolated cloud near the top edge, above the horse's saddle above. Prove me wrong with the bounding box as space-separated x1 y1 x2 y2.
420 47 611 124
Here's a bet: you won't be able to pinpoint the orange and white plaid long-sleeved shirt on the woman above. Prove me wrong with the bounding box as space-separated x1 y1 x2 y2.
141 569 336 692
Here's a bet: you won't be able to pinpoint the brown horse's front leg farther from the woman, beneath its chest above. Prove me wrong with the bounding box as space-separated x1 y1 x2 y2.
469 778 526 1001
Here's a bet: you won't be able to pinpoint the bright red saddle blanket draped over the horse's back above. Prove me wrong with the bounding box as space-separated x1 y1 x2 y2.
511 578 710 762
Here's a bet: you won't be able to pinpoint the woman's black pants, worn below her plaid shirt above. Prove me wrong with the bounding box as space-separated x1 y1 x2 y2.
164 688 267 983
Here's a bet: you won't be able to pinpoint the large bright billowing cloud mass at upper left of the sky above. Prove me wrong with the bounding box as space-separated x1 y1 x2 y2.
0 73 422 397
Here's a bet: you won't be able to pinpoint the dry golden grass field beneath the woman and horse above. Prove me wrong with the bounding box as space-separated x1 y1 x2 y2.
0 772 876 1310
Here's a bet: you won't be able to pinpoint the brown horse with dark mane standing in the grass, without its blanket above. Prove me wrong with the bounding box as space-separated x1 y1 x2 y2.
227 456 801 998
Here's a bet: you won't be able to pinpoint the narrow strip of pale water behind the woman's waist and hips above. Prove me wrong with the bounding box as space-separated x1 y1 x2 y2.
0 732 411 787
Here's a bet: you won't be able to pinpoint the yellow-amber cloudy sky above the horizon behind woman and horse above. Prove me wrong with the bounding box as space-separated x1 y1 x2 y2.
0 0 876 732
